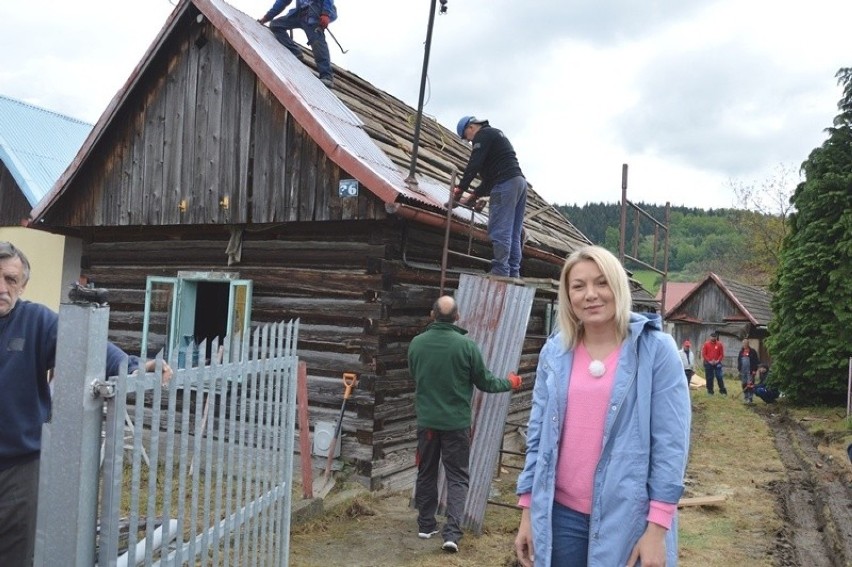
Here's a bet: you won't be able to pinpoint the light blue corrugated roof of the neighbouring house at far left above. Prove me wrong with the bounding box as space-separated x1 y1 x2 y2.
0 95 92 207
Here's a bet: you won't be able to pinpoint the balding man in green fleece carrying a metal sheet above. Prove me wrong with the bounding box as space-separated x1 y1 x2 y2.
408 295 521 553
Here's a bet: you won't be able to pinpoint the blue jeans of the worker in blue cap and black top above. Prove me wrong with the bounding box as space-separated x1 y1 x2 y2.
488 175 527 278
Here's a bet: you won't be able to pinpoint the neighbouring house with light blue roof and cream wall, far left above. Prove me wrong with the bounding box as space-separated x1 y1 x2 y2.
0 95 92 310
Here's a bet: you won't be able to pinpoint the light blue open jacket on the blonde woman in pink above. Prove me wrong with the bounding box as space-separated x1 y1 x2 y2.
517 313 692 567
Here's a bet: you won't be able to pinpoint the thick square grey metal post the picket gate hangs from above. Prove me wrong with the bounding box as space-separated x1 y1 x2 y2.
35 304 109 567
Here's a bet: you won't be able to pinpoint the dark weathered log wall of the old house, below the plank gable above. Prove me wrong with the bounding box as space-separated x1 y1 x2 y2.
76 212 555 489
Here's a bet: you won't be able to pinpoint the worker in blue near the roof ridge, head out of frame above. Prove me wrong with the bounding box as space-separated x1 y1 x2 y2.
258 0 337 88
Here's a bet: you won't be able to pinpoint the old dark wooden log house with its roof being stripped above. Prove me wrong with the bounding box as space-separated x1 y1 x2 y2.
33 0 654 488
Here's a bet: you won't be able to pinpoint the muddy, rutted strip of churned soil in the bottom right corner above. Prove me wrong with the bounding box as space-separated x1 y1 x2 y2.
760 406 852 567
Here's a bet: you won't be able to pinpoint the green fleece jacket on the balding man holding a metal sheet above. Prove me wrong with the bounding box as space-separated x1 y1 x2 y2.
408 322 512 431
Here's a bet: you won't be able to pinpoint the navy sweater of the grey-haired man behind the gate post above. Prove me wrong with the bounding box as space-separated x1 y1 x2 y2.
0 300 139 470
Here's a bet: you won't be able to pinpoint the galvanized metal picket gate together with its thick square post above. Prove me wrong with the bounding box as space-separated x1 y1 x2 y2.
36 305 298 567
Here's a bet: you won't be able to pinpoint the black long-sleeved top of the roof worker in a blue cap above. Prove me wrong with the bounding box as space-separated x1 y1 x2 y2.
459 125 524 198
